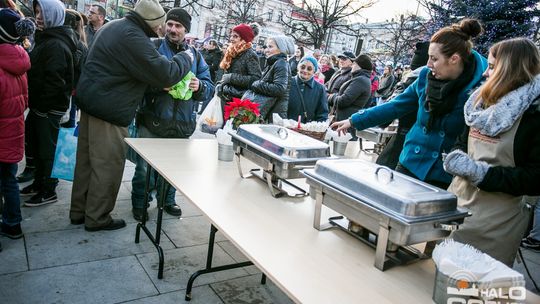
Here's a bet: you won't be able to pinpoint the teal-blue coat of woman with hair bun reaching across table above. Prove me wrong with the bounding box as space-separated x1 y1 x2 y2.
351 51 487 183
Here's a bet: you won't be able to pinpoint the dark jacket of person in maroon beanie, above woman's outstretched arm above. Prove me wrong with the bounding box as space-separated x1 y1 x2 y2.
328 69 371 121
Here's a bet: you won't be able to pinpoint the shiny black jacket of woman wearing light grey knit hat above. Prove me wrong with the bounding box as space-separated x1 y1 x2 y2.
251 53 291 121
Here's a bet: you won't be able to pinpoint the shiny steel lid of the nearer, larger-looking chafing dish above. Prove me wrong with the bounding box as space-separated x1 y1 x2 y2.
303 159 457 218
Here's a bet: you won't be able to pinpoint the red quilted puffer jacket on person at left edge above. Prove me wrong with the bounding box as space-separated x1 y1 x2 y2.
0 43 30 163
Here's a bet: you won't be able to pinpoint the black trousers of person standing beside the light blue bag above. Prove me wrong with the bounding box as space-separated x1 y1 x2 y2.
26 110 62 191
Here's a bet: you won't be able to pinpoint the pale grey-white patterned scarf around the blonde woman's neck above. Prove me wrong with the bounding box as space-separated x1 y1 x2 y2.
464 74 540 136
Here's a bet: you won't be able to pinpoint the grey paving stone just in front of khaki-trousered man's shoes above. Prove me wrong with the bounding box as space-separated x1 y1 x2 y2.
26 223 173 269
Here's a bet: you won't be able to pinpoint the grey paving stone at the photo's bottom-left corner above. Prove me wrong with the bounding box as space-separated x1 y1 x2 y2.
0 256 158 304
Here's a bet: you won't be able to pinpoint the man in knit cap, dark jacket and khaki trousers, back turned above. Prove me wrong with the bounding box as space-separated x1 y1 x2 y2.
69 0 193 231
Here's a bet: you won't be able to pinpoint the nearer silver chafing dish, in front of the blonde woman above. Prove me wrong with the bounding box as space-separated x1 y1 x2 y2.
302 159 470 270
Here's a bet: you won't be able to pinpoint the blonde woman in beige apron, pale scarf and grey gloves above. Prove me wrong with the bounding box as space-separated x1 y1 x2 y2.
444 38 540 267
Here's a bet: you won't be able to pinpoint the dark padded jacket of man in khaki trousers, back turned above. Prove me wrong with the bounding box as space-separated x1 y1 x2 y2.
77 12 192 127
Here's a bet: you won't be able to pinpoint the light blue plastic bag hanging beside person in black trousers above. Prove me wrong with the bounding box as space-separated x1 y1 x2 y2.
51 126 79 181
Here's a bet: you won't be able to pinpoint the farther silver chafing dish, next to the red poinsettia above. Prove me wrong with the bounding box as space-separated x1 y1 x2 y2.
231 124 330 197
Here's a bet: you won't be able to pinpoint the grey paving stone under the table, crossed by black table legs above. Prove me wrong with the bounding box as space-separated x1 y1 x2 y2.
137 245 248 297
